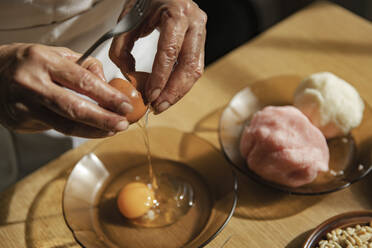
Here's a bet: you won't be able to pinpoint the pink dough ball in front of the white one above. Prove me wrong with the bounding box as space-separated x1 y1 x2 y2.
240 106 329 187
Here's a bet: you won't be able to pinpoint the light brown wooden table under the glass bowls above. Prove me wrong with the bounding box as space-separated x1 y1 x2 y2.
0 2 372 248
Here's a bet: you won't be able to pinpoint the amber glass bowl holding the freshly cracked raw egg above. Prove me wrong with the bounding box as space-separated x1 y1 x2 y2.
63 127 237 248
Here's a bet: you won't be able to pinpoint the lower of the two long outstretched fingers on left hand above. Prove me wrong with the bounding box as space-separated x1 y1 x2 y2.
38 83 129 132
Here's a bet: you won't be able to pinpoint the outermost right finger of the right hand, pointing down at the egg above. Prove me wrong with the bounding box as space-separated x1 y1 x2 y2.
153 17 206 113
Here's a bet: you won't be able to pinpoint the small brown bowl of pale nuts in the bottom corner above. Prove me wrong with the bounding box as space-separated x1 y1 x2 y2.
303 210 372 248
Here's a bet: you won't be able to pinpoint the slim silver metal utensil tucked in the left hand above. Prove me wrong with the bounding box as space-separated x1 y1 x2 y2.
76 0 150 65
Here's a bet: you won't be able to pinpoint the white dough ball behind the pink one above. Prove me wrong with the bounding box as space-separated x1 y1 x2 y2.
294 72 364 138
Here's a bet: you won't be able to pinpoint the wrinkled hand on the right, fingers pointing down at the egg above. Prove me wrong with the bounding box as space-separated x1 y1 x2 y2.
110 0 207 113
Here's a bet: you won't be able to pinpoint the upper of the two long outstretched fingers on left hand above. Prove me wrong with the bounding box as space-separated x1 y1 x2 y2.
48 57 133 115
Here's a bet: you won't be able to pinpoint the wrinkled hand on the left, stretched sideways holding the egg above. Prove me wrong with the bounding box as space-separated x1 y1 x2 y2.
0 44 132 138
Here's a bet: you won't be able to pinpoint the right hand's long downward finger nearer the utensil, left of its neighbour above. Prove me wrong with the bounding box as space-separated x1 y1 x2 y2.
146 10 188 102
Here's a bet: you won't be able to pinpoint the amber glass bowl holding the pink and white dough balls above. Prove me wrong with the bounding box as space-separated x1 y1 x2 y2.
219 75 372 195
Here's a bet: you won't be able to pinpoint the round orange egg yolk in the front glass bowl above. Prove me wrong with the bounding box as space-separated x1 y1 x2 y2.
117 182 155 219
